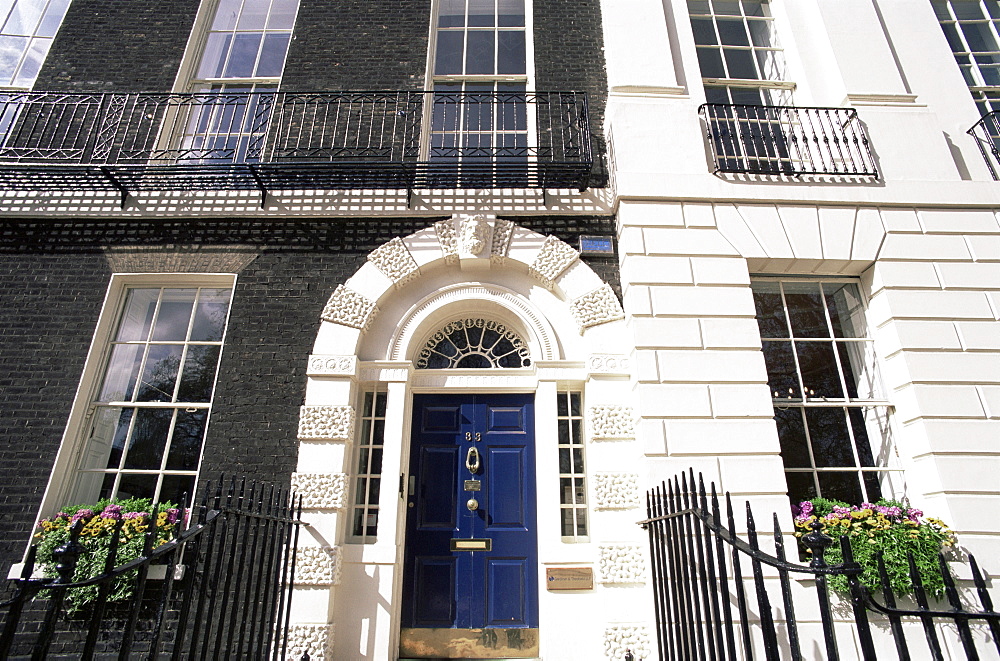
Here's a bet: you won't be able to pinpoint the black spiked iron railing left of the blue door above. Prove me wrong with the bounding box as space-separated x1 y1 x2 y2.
0 480 301 659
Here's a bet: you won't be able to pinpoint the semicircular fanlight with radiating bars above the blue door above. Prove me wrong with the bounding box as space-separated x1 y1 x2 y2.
417 319 531 369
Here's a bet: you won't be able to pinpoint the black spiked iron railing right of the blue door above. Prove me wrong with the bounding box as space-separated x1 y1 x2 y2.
640 471 1000 661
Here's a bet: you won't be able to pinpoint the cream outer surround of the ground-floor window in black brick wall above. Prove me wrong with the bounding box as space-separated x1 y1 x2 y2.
36 273 236 523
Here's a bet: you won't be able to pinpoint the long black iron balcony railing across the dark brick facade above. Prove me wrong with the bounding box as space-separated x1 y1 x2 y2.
0 91 592 199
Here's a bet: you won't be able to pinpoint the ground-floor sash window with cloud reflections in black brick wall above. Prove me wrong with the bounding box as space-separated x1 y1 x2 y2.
69 287 232 503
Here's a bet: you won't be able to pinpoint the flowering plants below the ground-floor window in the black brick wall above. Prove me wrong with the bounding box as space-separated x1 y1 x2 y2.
35 498 180 613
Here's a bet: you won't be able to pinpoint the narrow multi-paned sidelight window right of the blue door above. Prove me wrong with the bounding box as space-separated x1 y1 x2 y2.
557 391 588 541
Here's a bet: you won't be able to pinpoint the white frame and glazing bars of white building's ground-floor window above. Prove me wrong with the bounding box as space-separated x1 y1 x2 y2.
751 275 905 505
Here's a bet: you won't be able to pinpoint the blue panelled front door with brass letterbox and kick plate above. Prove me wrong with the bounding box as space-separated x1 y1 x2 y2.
400 394 538 658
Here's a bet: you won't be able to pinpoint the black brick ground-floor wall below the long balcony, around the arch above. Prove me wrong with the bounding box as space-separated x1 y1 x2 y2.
0 216 620 574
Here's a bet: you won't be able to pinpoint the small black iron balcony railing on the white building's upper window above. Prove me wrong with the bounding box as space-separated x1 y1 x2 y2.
699 103 878 177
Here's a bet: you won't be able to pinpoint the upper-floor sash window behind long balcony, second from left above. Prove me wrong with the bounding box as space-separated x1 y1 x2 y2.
172 0 298 163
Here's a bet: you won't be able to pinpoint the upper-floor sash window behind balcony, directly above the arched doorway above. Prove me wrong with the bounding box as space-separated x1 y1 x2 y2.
429 0 530 175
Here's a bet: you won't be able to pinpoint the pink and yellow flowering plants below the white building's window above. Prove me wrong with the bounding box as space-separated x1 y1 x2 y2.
792 498 954 597
